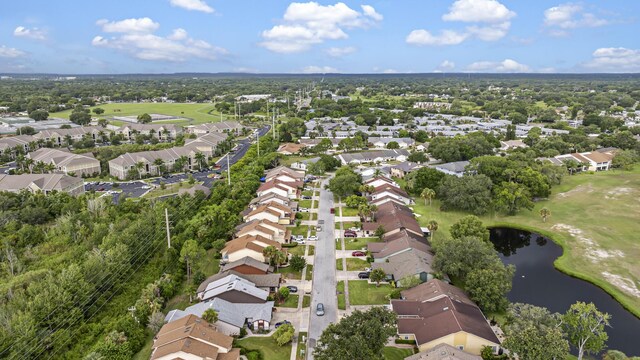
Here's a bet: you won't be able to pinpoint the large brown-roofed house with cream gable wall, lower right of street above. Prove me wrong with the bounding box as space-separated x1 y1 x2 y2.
391 279 500 355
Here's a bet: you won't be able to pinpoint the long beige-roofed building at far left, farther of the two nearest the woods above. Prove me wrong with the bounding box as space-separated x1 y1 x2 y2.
27 148 101 177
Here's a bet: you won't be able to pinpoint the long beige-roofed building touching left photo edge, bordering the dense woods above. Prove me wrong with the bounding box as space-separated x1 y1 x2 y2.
0 174 84 196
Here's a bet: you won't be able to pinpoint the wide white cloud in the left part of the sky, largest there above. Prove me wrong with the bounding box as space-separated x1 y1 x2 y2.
91 18 228 62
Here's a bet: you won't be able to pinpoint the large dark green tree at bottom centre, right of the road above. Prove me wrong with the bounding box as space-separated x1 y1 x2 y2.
313 307 397 360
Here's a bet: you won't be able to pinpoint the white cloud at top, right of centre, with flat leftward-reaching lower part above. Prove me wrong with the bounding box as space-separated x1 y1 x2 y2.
406 0 516 45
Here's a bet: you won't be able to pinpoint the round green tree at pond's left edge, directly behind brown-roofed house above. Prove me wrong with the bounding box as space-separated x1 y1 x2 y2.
465 261 516 312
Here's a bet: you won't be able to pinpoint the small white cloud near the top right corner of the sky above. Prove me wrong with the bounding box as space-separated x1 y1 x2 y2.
544 3 609 32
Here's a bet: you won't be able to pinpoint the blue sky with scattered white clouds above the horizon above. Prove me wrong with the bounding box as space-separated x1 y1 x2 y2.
0 0 640 74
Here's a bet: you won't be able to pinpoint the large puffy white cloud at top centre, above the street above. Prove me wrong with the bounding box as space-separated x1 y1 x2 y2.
260 2 382 53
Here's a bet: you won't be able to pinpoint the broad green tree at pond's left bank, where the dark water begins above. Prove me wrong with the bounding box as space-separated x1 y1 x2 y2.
432 236 500 277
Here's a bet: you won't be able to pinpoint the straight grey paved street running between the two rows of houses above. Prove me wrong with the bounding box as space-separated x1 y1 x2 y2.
308 179 338 359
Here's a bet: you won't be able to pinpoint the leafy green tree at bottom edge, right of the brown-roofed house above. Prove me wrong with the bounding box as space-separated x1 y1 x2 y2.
503 303 569 360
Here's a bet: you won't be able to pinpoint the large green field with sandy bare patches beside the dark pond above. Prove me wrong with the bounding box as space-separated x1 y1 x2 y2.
414 167 640 317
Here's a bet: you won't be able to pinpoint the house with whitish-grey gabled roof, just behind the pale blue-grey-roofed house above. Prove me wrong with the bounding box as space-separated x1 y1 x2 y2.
198 274 269 304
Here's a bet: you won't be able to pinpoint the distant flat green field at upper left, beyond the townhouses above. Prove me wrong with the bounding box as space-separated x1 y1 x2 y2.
50 103 233 125
